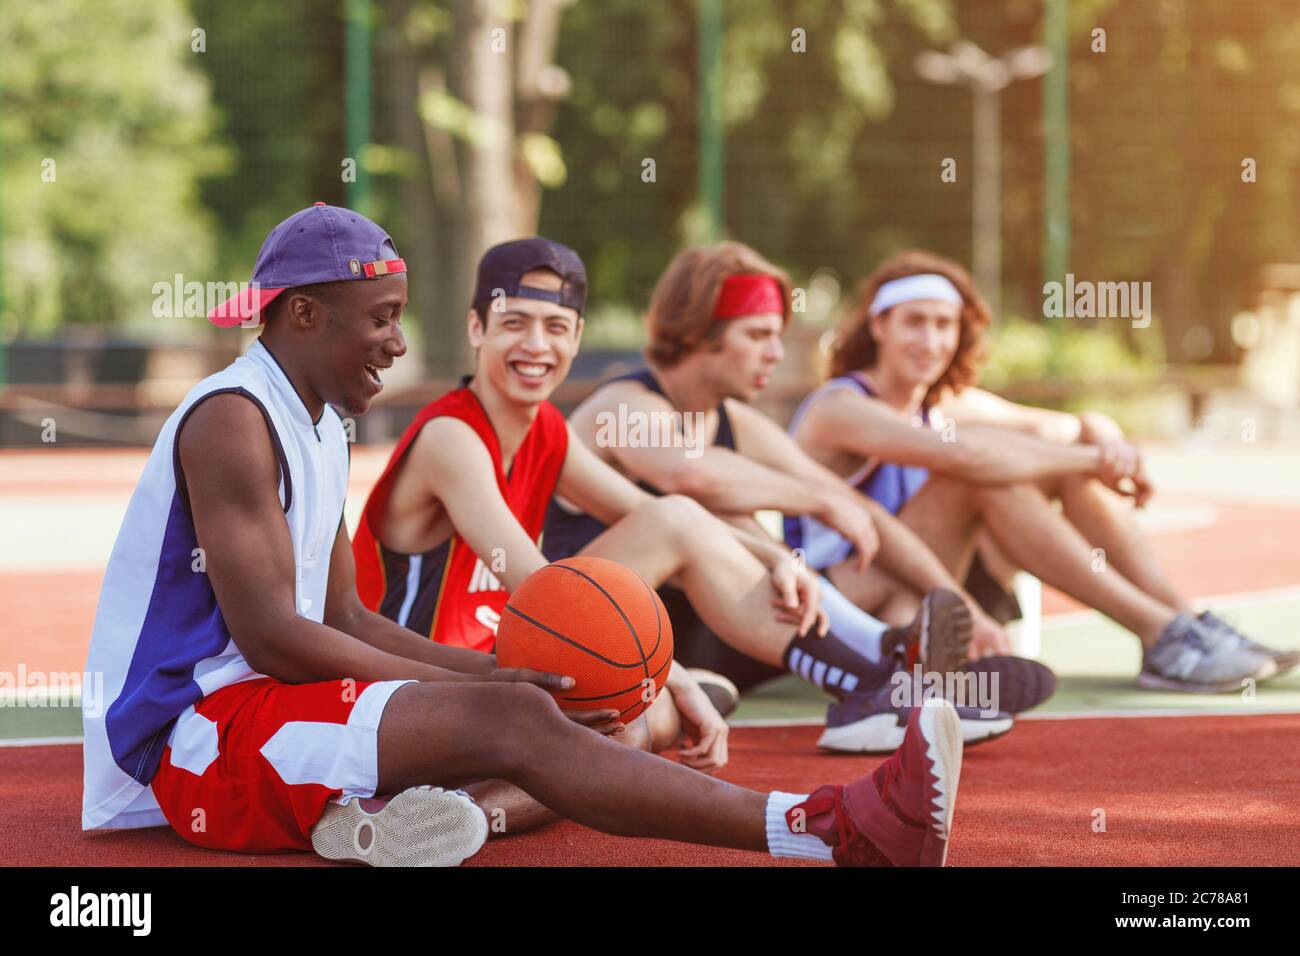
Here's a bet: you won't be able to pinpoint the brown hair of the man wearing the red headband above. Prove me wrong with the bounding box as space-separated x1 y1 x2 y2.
646 242 790 368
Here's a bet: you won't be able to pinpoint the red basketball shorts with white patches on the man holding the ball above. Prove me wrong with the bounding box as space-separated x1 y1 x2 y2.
152 678 408 853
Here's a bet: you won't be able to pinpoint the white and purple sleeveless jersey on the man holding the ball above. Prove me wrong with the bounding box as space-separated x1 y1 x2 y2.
82 339 348 830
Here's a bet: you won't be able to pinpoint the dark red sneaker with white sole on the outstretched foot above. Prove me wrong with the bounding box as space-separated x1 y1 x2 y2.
785 698 962 866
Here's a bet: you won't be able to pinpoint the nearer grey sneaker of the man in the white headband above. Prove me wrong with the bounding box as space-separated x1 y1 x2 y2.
1138 614 1278 693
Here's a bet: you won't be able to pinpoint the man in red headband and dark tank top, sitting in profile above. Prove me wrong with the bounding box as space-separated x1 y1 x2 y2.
542 242 1049 752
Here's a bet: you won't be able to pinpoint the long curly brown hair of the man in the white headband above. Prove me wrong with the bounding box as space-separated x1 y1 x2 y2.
829 250 989 405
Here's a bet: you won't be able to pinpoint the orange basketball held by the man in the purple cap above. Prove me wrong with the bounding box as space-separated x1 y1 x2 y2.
497 558 672 722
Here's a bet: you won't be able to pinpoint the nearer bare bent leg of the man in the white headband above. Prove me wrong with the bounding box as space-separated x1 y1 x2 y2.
900 476 1177 646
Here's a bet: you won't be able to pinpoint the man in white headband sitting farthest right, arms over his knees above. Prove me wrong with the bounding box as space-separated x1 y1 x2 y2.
787 252 1300 693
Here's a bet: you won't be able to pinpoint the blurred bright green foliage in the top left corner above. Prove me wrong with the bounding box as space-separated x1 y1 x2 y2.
0 0 228 336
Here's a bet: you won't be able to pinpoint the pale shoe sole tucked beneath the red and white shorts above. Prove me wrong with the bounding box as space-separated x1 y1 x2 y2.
312 787 488 866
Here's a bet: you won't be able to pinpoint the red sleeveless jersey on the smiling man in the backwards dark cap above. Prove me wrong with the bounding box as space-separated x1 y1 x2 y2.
352 388 568 653
